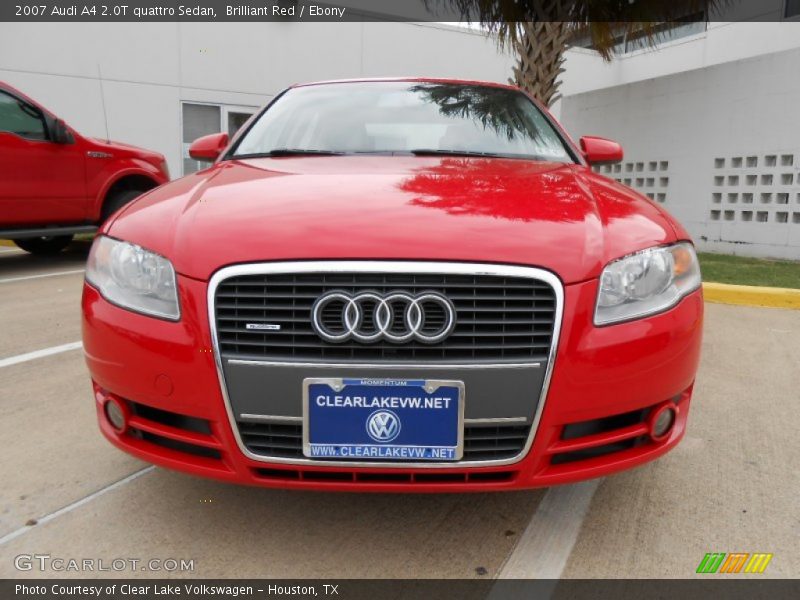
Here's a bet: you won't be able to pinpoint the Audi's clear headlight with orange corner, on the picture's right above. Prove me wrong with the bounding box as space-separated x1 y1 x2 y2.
594 242 700 325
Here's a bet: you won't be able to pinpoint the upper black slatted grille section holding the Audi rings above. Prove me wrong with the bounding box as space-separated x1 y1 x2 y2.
214 271 555 364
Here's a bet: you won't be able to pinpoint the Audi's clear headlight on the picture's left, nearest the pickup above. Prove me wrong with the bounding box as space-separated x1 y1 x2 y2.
86 236 181 321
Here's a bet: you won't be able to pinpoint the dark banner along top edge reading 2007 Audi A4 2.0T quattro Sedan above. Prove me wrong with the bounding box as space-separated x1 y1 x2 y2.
0 0 800 23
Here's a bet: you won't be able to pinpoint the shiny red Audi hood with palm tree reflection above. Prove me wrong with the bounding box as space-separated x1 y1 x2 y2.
105 156 675 283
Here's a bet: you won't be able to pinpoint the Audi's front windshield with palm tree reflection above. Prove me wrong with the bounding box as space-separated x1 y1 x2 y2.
232 81 573 162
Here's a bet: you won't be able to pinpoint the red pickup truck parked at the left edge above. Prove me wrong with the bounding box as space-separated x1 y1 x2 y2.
0 82 169 254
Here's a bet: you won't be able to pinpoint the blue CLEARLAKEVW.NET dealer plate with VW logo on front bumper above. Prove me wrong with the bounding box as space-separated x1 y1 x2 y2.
303 379 464 462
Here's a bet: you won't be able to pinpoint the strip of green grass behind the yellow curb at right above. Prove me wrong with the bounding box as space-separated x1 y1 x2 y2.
697 252 800 289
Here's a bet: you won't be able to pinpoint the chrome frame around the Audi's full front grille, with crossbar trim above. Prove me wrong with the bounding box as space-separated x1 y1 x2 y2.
207 260 564 469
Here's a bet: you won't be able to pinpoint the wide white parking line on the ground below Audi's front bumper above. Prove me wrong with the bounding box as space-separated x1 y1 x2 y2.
498 479 602 579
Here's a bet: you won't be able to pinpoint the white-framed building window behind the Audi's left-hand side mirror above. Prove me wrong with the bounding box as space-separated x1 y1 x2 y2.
182 102 257 175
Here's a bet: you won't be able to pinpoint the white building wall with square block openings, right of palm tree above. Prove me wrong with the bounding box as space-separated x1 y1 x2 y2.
561 42 800 259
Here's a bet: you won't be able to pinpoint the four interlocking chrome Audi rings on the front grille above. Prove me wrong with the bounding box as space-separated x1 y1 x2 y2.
311 291 456 344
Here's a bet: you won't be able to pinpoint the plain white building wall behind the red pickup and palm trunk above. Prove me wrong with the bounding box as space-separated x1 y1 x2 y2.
0 22 512 175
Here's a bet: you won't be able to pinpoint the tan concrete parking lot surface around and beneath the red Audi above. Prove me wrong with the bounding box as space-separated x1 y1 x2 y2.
0 243 800 578
